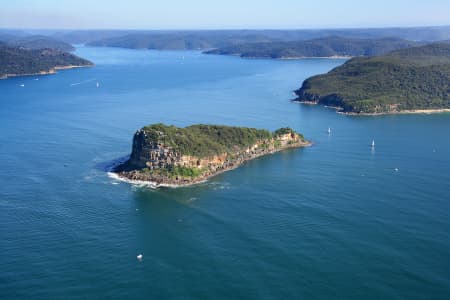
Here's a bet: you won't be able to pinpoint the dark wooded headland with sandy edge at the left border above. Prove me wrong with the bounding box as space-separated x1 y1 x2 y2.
0 43 93 79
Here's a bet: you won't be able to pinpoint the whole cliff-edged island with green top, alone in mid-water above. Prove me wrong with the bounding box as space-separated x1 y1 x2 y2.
112 124 310 187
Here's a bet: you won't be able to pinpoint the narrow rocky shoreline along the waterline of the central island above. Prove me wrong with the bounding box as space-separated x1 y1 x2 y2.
112 141 313 189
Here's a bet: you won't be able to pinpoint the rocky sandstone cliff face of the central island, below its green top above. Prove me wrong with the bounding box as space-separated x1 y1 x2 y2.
116 125 308 185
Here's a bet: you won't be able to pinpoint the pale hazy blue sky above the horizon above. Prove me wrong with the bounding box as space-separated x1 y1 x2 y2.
0 0 450 29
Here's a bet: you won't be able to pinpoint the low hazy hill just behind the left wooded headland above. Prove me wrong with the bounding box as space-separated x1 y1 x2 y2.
5 35 75 51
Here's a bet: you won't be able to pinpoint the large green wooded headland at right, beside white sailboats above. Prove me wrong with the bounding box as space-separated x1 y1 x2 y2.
293 43 450 115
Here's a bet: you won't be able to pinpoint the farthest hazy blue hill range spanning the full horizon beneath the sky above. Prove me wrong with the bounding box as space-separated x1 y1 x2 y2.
0 26 450 49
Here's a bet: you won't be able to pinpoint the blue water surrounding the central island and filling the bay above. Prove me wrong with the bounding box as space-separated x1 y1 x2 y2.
0 48 450 299
